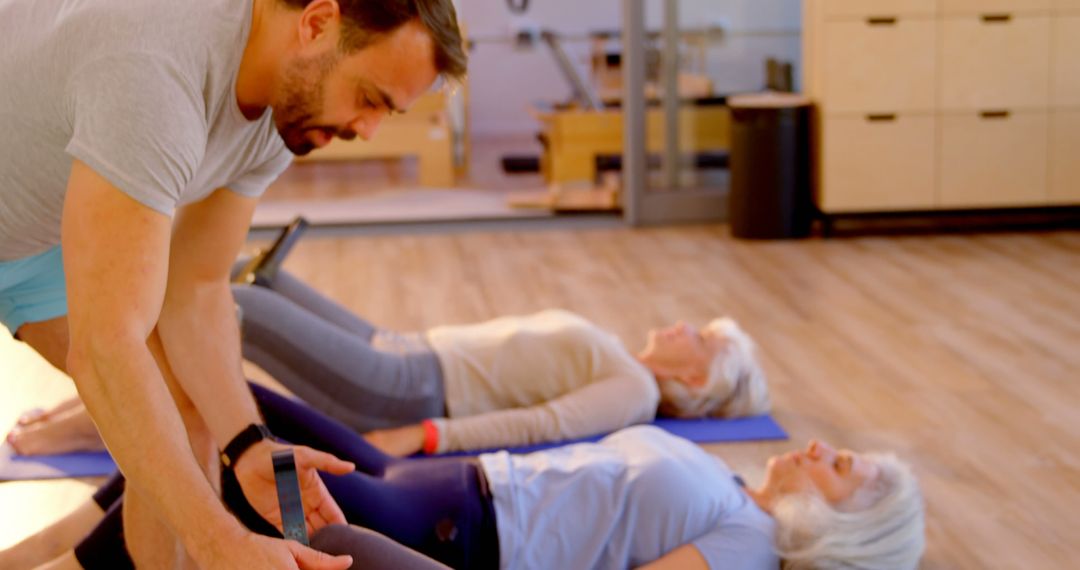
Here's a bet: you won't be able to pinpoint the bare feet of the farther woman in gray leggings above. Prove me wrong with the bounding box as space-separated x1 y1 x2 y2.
8 403 105 456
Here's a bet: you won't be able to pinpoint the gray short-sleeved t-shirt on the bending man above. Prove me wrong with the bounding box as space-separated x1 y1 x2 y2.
0 0 292 260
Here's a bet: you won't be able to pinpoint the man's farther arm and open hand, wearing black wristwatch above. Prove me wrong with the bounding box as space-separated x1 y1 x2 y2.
158 189 353 530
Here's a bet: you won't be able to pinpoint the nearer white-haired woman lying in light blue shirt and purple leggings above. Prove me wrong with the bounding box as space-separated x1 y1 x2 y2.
0 382 924 570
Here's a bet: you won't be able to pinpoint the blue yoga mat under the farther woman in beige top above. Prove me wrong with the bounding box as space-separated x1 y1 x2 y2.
0 416 787 481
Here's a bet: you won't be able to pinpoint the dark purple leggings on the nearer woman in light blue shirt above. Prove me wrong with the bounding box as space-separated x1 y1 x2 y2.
76 384 499 568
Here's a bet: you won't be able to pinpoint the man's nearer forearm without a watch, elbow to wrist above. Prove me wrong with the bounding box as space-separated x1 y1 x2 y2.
68 331 243 553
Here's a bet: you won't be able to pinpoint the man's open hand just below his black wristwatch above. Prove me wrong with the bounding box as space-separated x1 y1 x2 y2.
234 439 355 532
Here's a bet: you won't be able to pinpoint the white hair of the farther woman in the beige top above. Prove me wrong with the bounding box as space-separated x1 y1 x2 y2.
659 317 770 418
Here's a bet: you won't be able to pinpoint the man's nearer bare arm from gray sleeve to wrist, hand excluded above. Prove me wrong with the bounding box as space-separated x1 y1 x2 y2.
62 162 243 551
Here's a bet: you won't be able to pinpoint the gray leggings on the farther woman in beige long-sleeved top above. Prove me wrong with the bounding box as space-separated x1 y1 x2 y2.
232 267 446 433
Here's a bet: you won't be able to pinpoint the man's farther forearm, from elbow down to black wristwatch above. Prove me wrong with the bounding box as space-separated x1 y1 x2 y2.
157 279 259 449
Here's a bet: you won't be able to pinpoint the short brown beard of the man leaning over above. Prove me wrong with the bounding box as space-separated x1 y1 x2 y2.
273 51 355 157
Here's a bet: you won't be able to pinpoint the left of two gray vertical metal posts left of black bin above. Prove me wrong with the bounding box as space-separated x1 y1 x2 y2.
622 0 647 226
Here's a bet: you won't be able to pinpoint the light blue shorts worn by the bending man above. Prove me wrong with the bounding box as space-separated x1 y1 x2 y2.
0 245 67 335
